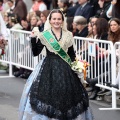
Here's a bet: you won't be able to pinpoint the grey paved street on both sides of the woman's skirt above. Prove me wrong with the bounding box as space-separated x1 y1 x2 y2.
0 74 120 120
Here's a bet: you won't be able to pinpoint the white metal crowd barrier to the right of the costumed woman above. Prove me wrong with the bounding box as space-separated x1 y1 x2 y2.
74 37 120 110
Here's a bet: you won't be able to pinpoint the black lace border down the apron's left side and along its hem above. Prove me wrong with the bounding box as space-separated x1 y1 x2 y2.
30 59 89 120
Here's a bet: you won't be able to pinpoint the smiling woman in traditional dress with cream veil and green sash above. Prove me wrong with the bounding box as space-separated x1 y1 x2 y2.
19 9 93 120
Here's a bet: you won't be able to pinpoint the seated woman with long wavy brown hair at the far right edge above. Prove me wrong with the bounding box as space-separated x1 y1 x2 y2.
93 18 120 96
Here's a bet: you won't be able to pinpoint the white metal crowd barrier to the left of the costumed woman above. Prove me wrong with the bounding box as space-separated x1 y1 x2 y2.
0 29 46 77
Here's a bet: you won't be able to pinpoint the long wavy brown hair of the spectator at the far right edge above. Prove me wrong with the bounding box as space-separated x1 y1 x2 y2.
108 18 120 43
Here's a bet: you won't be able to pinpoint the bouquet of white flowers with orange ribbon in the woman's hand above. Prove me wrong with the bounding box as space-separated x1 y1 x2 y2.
71 58 89 83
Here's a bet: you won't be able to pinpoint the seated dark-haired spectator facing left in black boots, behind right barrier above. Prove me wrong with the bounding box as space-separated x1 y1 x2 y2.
86 18 110 100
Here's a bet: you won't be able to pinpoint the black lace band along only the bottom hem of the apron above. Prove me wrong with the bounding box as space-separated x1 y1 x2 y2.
30 94 87 120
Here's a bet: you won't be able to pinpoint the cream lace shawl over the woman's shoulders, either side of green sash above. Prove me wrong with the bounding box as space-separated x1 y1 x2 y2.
32 27 74 54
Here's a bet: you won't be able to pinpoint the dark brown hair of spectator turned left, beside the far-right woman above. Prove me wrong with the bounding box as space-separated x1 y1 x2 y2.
95 18 108 38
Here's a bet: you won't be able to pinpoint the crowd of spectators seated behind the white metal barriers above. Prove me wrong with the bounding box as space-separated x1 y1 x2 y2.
0 0 120 99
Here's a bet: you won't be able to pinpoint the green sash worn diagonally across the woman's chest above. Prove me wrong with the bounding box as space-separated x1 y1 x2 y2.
42 31 71 65
